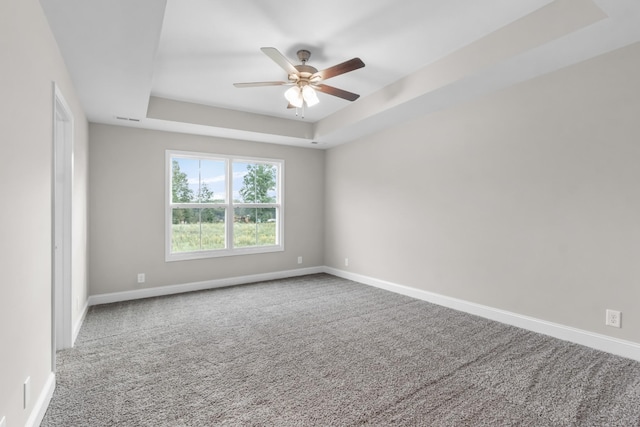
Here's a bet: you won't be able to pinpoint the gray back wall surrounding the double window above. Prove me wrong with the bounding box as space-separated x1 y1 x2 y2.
89 124 325 295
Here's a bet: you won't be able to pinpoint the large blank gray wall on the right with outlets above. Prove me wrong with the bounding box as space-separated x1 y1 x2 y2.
325 44 640 342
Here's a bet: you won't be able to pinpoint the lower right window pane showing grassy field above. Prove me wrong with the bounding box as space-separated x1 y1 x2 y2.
233 208 277 248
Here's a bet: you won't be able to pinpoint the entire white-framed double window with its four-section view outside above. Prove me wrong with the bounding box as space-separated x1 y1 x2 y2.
166 151 284 261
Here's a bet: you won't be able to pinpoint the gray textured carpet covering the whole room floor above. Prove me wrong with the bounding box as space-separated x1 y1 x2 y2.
42 274 640 427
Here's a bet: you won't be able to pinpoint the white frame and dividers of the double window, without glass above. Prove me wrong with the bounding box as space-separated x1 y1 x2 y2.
165 150 284 262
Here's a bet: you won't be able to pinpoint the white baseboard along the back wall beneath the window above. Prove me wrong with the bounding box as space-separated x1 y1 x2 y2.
88 267 325 306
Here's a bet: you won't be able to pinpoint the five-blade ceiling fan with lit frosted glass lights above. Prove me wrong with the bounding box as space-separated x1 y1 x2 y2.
233 47 364 117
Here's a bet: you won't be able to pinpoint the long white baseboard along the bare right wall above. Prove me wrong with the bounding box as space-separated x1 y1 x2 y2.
324 267 640 361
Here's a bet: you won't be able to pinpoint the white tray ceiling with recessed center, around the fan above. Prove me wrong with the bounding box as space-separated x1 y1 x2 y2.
40 0 640 148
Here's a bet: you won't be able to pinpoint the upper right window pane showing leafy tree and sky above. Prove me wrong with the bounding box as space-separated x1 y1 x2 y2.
233 162 277 203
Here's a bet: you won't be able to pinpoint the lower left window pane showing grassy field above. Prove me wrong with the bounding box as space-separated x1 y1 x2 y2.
171 208 226 253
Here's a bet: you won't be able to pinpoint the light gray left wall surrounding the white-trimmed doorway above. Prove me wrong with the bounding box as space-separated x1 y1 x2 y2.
0 0 88 426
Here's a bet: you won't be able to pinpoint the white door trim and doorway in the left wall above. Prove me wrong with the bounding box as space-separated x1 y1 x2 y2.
52 82 73 372
